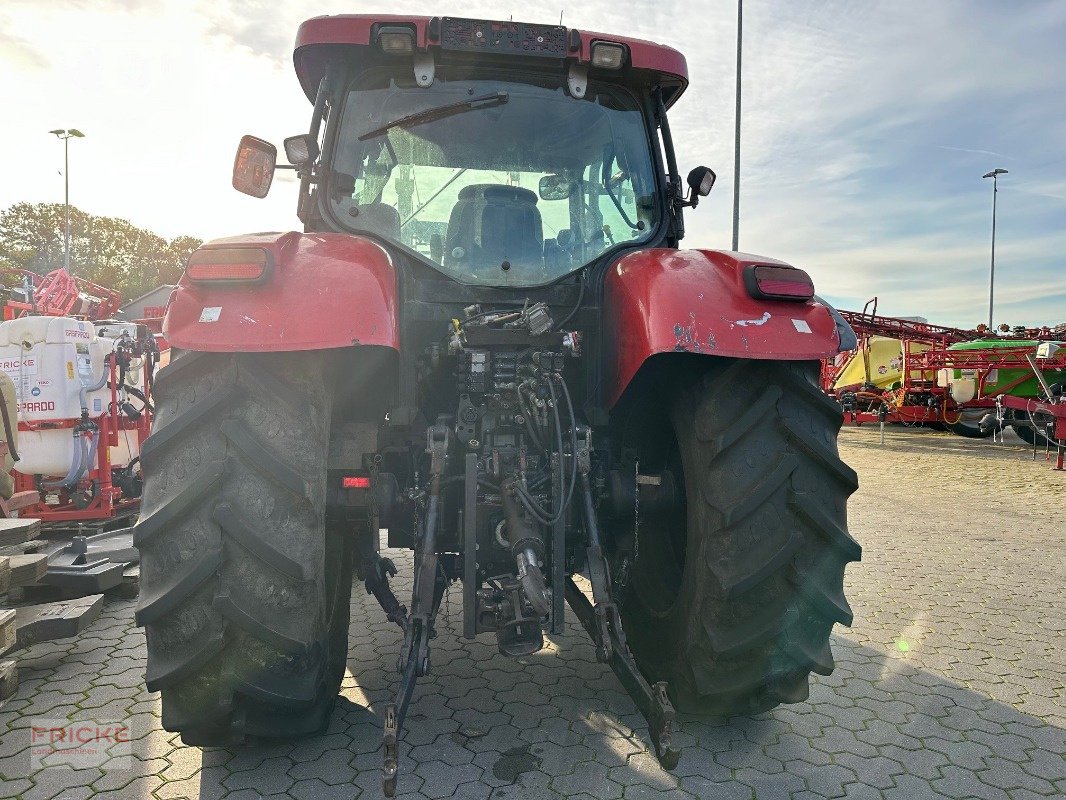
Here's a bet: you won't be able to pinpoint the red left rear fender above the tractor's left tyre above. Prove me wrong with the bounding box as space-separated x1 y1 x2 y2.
163 231 400 352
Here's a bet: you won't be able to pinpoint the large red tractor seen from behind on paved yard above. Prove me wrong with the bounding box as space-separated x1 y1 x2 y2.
136 15 860 794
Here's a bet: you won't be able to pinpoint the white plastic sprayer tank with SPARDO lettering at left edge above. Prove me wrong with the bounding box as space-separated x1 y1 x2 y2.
0 317 114 477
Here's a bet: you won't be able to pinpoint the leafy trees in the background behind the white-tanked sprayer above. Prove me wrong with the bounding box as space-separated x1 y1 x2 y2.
0 203 200 299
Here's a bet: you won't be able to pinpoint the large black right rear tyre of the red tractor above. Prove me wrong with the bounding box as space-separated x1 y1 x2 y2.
615 359 861 716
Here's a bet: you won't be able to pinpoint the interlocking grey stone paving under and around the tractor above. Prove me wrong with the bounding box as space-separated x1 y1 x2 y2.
0 427 1066 800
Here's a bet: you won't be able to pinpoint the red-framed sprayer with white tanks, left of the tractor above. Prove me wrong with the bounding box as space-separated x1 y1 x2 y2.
0 269 159 525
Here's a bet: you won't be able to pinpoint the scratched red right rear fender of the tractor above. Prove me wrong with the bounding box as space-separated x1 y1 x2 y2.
603 250 850 407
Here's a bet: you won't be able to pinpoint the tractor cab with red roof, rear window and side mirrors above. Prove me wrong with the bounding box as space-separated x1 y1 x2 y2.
235 16 710 288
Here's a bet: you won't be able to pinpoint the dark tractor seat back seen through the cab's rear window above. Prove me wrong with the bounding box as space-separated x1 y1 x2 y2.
443 183 544 272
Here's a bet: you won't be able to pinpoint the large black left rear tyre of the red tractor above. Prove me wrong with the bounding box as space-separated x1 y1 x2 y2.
134 352 353 746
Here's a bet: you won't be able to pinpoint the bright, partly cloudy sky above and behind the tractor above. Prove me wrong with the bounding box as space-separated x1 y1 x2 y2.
0 0 1066 327
